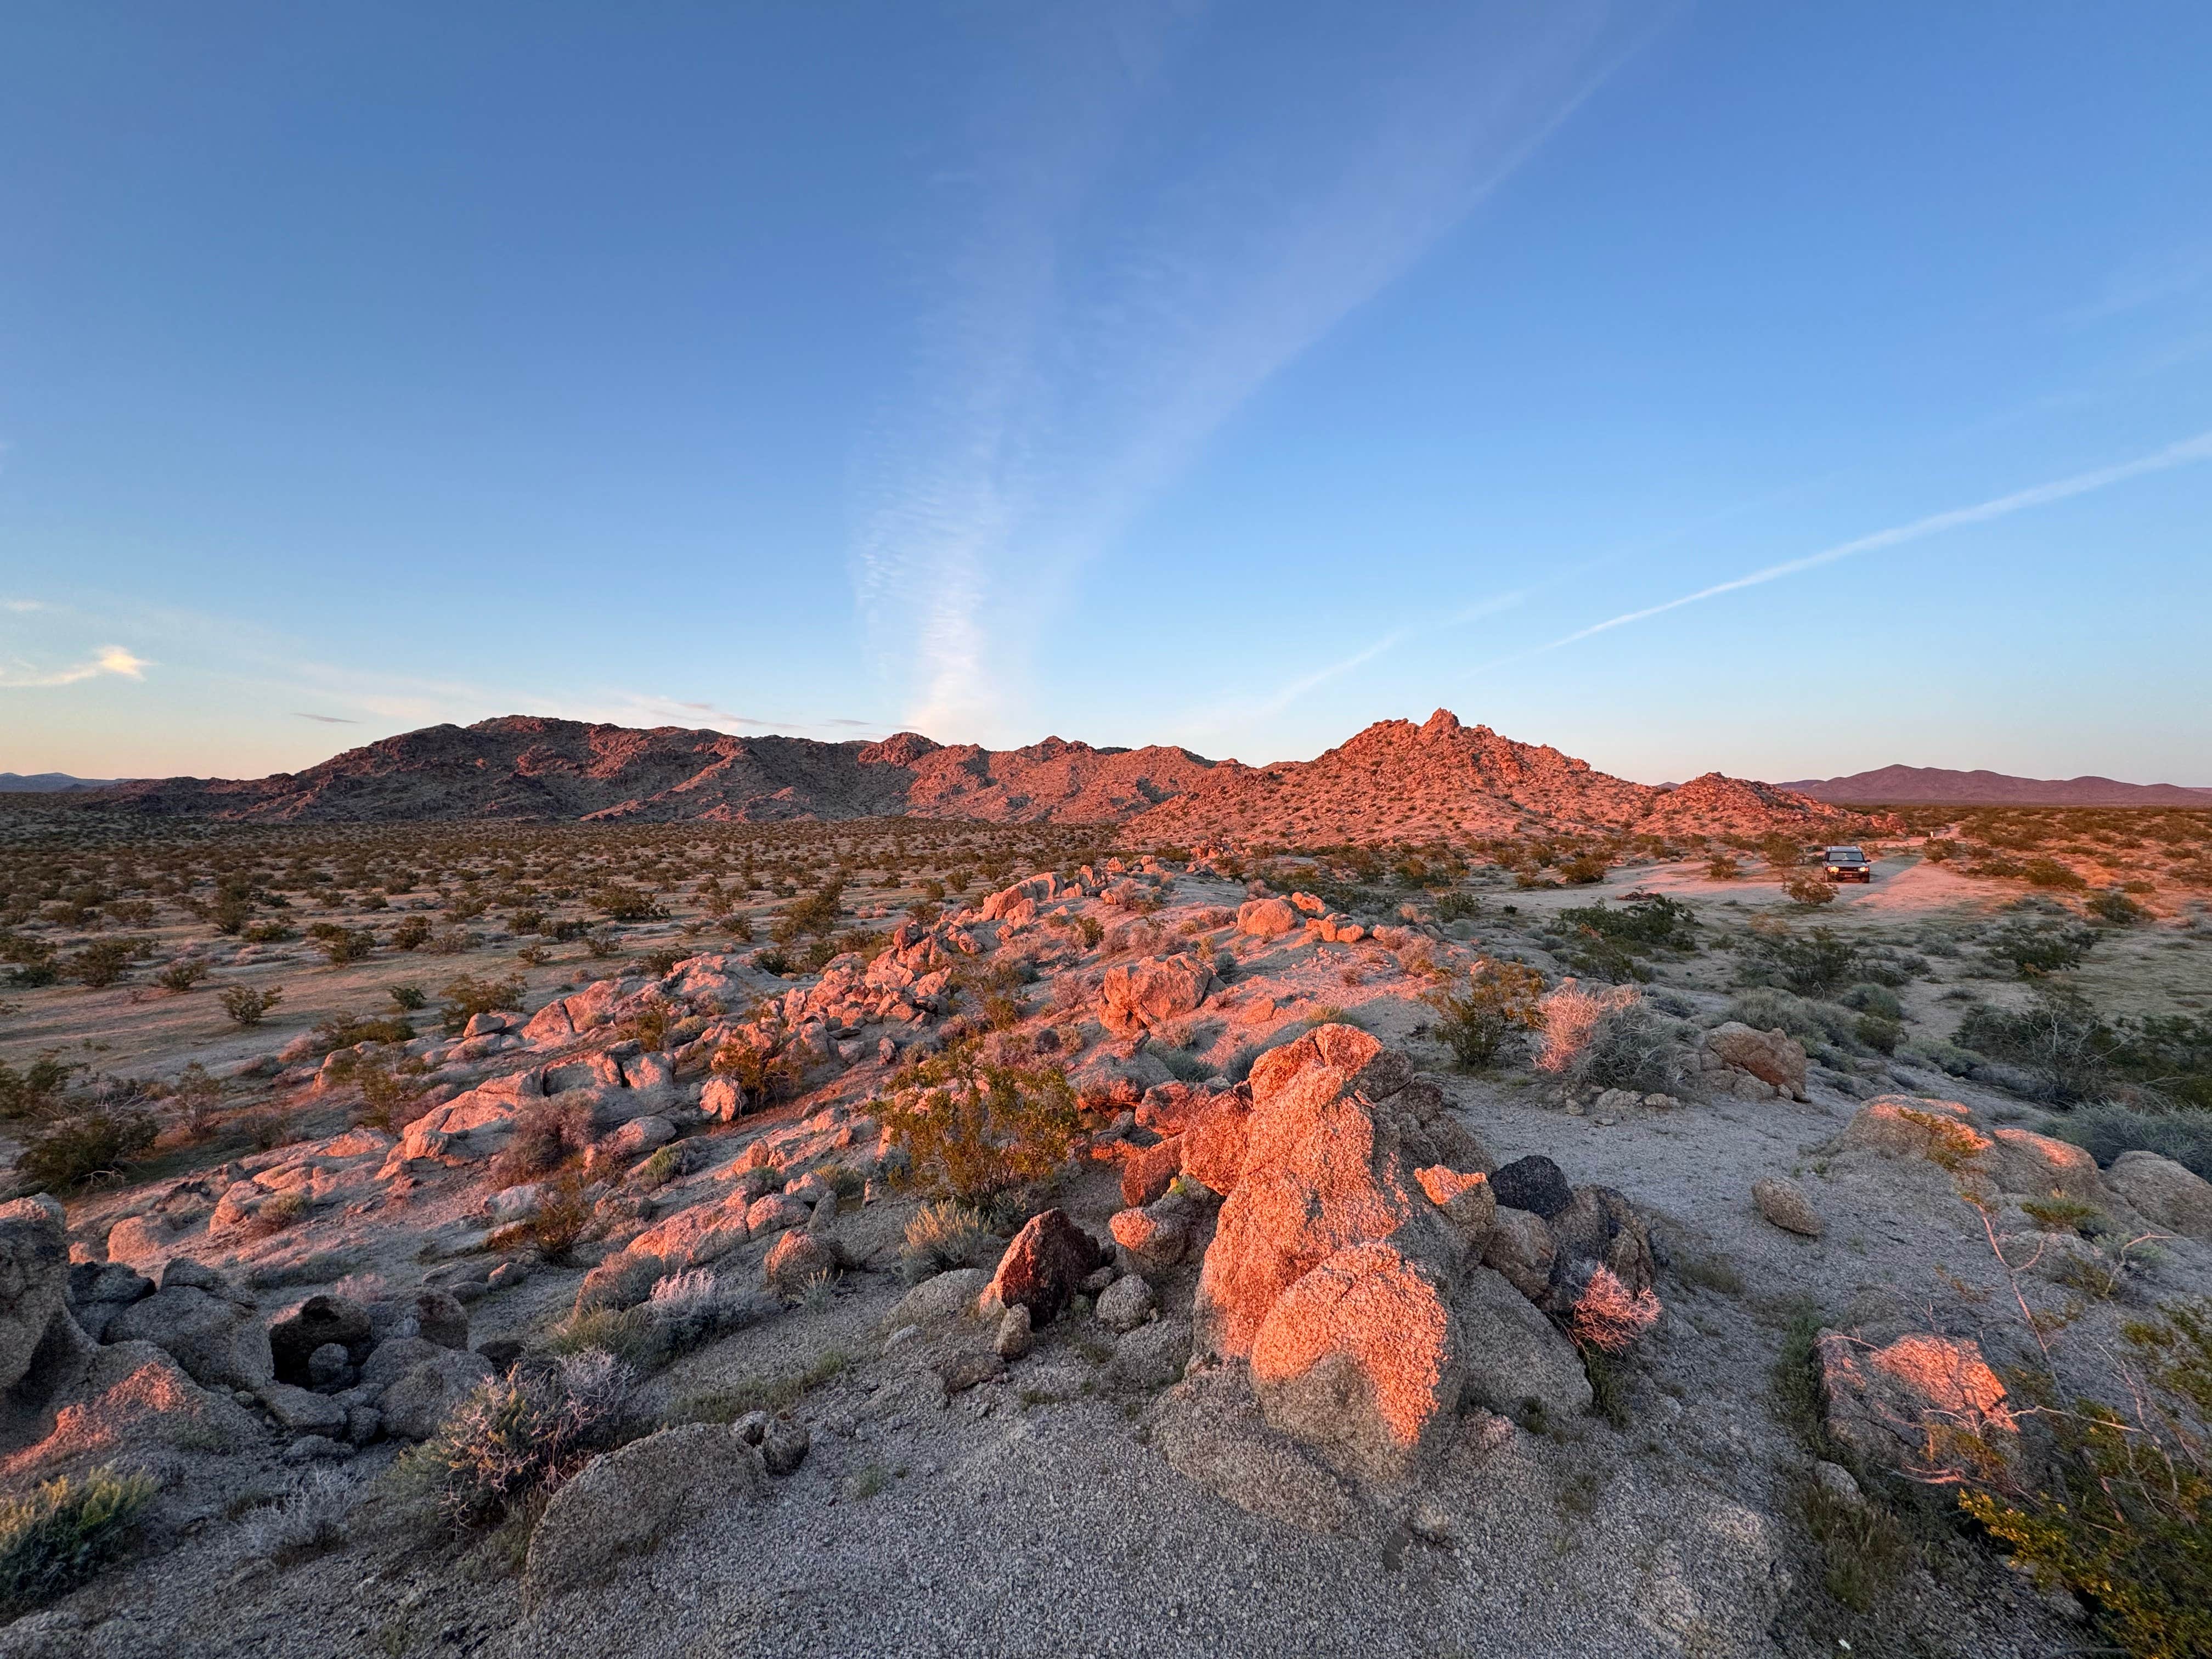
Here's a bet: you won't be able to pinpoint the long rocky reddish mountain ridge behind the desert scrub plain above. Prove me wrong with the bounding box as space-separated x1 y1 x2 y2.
64 710 1856 845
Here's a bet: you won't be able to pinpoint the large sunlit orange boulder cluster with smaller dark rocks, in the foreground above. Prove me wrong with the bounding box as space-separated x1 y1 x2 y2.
1150 1024 1657 1526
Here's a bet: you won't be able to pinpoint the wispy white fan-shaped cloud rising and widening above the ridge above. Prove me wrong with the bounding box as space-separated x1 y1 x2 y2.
854 2 1644 737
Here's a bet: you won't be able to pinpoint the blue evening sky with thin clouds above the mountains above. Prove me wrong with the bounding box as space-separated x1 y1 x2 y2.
0 0 2212 783
